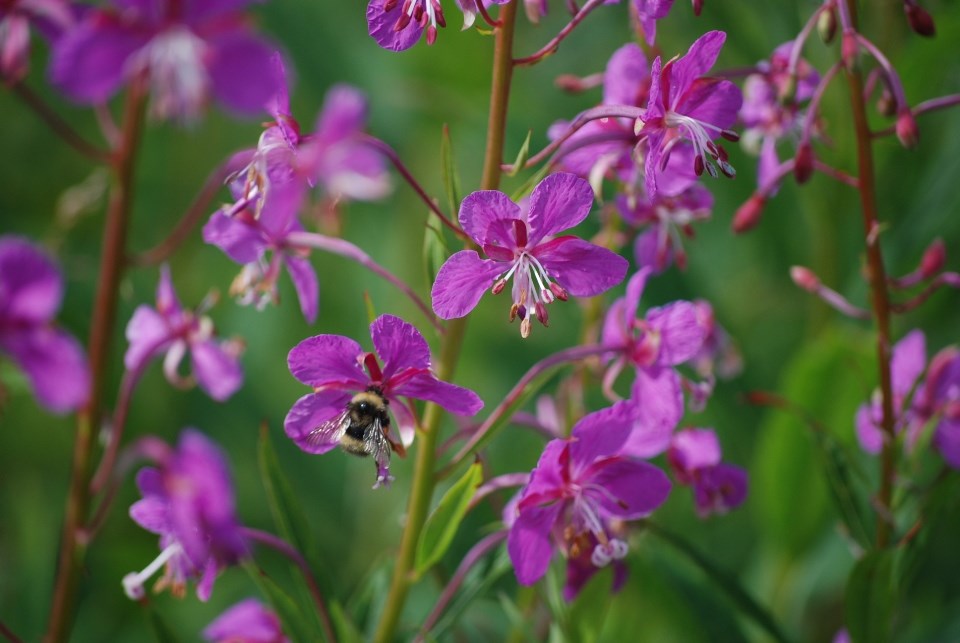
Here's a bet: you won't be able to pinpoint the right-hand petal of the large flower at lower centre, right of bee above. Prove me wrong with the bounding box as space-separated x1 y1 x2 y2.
582 458 671 520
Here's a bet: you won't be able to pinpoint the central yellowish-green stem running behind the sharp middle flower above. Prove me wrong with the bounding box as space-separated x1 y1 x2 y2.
374 1 517 643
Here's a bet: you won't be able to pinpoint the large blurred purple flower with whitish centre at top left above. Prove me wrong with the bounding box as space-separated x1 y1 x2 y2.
50 0 277 121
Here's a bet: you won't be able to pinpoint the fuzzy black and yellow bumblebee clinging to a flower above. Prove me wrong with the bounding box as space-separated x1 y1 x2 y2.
306 386 406 484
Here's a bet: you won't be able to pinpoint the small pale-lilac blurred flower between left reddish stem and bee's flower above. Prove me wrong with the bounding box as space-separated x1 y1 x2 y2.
123 266 243 402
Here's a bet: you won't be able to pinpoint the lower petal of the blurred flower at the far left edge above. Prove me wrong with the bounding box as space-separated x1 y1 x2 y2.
0 326 90 413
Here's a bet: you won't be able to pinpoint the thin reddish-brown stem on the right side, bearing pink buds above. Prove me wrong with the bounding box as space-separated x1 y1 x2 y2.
845 0 896 547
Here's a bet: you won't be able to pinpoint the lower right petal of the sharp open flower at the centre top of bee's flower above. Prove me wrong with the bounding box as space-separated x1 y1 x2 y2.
533 237 630 297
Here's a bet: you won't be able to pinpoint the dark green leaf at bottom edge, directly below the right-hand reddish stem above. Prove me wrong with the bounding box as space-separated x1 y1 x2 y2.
845 549 896 643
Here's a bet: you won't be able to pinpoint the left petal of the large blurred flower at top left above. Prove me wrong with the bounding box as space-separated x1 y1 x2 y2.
50 20 144 103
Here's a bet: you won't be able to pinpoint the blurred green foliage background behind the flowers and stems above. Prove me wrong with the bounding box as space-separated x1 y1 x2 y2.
0 0 960 641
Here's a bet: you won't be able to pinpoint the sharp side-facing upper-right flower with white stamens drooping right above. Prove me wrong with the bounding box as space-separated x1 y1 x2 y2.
634 31 743 198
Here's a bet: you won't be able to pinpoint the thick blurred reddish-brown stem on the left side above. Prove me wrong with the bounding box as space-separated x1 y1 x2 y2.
44 79 146 643
